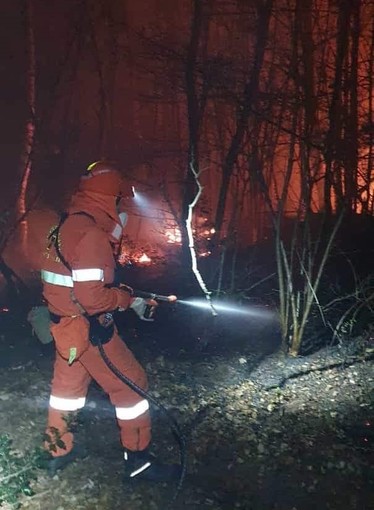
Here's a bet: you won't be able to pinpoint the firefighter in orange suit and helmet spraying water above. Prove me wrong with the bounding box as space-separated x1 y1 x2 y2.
41 161 176 481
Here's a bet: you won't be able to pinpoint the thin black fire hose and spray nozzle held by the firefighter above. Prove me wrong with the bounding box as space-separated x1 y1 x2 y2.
97 290 187 508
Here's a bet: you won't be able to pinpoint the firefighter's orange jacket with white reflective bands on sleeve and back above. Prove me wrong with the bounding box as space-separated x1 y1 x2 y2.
42 192 132 317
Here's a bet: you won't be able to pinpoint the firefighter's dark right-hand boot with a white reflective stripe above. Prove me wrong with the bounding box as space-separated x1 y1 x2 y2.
124 450 180 482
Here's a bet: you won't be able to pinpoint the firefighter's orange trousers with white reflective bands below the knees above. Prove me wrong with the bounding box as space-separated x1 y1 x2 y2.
45 332 151 456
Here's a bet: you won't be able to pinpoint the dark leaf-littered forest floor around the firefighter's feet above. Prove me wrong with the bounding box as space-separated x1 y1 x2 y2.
0 302 374 510
